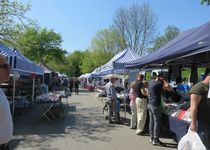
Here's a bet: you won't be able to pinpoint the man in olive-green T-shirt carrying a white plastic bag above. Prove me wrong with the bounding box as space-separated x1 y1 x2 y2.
190 73 210 150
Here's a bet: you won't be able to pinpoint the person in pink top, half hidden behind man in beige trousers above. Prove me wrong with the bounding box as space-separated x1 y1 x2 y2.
129 81 137 129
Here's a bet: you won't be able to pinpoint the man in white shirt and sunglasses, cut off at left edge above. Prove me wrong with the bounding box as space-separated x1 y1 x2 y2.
0 55 13 150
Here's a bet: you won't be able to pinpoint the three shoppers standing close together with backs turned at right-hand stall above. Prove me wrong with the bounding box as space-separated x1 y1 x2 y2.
126 74 170 145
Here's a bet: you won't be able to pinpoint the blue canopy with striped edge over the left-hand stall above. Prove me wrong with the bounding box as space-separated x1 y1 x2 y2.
0 44 44 74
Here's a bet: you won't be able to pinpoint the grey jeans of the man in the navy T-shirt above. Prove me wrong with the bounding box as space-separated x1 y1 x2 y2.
148 104 162 138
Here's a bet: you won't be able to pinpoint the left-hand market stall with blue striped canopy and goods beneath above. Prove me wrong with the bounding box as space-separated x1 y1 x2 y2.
0 44 43 116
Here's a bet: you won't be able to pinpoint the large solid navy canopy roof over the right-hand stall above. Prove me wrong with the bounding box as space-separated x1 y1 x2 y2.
125 22 210 68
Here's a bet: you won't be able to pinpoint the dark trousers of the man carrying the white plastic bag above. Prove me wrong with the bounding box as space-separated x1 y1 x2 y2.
198 121 210 150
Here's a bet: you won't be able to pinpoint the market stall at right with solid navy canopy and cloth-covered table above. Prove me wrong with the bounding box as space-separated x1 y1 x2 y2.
125 22 210 141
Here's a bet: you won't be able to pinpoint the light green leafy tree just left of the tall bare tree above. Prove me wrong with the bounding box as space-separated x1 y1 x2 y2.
80 29 118 73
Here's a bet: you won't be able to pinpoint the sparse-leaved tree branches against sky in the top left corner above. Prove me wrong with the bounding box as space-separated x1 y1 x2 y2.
0 0 34 45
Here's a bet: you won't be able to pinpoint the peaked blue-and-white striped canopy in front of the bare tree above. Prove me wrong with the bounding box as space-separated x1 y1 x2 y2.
95 49 140 75
